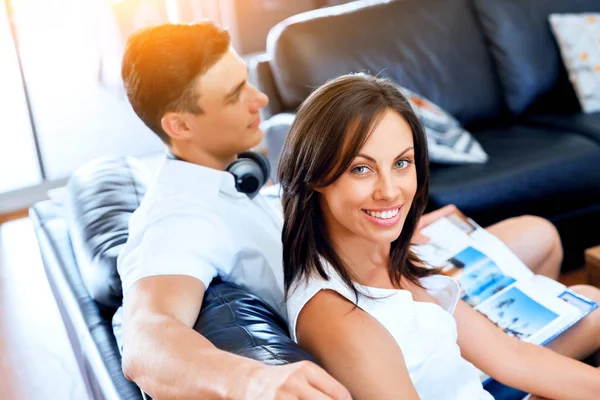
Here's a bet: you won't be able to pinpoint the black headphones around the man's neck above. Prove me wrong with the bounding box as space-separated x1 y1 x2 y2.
167 151 271 199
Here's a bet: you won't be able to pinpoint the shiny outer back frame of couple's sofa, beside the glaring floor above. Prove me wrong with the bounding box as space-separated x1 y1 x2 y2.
29 200 142 400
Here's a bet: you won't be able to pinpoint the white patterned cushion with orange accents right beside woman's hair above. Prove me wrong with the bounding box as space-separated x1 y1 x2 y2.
400 87 488 164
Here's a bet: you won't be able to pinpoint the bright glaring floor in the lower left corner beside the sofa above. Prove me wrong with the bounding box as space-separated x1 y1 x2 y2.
0 218 87 400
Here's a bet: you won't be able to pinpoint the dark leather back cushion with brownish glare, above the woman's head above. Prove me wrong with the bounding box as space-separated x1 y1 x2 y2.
267 0 503 124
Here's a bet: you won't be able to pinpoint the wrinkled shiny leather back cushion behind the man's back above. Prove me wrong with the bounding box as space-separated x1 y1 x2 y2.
67 157 150 316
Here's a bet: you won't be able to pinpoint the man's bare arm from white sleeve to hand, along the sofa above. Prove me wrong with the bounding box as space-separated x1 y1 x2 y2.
123 275 350 400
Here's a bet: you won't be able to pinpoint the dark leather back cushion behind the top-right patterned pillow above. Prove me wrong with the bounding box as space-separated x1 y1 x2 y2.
473 0 600 116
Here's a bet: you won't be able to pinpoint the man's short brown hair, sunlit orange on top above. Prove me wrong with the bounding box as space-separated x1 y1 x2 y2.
121 22 230 144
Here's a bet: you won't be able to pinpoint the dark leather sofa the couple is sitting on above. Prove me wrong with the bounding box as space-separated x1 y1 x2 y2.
34 158 524 400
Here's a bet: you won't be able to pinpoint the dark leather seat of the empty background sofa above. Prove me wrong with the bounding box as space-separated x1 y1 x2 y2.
430 125 600 224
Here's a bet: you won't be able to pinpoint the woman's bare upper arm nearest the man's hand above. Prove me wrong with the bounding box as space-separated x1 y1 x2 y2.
296 290 419 400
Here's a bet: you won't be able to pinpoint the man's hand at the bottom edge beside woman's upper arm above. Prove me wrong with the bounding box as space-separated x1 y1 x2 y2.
239 361 352 400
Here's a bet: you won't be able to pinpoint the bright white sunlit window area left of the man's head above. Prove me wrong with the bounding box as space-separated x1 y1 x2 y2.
15 0 163 180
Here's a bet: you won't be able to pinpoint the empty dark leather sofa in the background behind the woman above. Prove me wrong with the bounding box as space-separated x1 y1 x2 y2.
251 0 600 270
